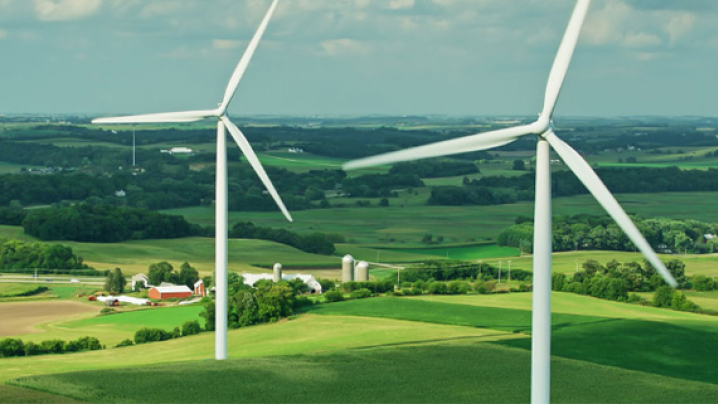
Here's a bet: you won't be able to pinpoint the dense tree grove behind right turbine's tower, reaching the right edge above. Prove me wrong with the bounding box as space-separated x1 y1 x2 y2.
496 214 718 254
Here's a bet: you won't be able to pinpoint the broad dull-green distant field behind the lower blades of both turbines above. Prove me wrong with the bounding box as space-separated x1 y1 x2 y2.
164 192 718 245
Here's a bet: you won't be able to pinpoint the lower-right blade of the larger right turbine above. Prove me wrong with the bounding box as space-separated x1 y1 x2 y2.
545 130 677 287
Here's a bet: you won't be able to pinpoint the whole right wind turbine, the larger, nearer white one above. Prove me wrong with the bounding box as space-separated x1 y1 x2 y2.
344 0 676 404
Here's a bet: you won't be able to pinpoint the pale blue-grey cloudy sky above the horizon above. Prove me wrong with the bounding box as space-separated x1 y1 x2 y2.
0 0 718 117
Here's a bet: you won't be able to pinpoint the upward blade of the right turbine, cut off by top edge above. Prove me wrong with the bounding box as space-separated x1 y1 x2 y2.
541 0 591 119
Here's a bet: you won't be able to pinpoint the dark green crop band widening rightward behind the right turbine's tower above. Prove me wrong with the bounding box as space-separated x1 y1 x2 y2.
309 298 718 384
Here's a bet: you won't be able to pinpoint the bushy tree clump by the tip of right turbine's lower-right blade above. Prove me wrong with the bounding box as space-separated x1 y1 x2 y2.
552 259 689 302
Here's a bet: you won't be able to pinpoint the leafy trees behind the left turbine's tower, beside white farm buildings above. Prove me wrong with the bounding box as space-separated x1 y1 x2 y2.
200 273 312 331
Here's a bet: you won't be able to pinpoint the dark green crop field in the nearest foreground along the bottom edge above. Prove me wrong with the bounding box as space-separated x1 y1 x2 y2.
16 343 718 403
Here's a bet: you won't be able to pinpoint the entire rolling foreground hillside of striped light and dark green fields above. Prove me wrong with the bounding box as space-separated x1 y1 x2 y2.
5 293 718 403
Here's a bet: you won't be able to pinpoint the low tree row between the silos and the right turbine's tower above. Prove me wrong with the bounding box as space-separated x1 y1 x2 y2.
401 261 531 282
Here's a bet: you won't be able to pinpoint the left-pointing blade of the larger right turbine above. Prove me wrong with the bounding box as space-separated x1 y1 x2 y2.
342 125 534 170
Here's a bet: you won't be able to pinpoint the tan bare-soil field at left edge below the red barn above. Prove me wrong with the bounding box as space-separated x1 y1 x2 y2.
0 301 99 337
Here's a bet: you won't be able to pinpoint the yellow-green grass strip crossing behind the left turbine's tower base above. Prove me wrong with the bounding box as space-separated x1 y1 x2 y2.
0 315 506 382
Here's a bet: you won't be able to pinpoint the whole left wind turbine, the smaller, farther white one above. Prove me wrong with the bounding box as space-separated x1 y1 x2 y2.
92 0 292 360
